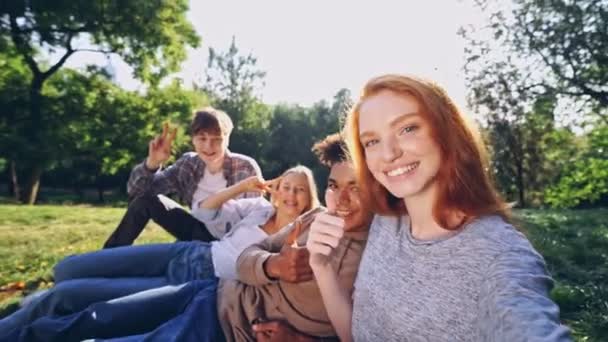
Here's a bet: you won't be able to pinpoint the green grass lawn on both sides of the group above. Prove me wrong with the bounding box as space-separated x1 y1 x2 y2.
0 205 608 341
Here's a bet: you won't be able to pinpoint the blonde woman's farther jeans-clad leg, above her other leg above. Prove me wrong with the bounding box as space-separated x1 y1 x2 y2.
54 242 197 283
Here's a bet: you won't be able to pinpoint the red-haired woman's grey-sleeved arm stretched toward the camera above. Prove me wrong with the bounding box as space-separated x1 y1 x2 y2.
478 247 572 341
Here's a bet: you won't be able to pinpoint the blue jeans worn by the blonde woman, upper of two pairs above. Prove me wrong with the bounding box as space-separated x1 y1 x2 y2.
0 242 215 339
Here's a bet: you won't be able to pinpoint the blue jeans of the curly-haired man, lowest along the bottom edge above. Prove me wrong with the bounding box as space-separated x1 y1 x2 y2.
0 279 224 342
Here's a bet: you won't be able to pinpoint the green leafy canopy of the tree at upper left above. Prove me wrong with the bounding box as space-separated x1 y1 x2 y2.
0 0 200 82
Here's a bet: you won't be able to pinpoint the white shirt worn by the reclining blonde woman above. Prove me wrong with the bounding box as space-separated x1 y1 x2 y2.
192 197 275 279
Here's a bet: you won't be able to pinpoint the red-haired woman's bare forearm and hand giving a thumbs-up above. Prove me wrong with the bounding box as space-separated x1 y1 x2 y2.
306 213 353 342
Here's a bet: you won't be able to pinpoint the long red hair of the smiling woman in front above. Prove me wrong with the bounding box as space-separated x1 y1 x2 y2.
345 74 510 229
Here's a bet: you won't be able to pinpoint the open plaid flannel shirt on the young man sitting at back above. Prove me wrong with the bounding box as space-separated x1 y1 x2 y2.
127 151 262 207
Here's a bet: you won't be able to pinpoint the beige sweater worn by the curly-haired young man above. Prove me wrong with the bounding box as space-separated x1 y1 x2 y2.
218 218 368 341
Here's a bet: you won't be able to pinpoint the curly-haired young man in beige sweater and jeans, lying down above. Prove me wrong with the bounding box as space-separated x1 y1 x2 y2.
0 135 370 341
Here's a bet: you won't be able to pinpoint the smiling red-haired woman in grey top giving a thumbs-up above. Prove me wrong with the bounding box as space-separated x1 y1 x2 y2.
309 75 570 341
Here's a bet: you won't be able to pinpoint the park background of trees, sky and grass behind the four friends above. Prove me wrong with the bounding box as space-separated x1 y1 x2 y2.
0 0 608 341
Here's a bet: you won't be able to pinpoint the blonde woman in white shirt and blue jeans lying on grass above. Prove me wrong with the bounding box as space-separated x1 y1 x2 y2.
0 166 319 340
